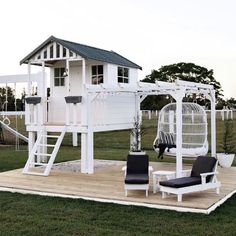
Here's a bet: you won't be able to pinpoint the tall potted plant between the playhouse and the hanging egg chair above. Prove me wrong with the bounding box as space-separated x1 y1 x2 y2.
129 115 146 155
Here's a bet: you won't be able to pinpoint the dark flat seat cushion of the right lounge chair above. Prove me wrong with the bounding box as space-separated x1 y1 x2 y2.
160 177 201 188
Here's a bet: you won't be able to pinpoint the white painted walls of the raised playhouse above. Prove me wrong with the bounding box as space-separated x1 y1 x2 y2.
49 60 138 129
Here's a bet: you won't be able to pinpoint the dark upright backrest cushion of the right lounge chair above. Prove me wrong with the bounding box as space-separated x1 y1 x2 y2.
191 156 216 182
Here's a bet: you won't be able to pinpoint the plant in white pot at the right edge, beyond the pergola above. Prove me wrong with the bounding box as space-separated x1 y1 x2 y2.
217 119 236 168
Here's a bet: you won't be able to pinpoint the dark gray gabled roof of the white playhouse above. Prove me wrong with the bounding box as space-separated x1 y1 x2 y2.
20 36 142 69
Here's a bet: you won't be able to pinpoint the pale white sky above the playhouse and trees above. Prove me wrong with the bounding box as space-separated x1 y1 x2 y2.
0 0 236 98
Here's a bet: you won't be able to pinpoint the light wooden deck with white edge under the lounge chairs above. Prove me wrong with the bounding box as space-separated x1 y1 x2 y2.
0 161 236 213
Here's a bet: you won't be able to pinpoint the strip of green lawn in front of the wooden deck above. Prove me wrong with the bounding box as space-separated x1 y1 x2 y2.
0 192 236 236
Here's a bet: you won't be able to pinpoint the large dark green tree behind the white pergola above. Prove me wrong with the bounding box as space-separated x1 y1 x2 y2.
142 62 223 109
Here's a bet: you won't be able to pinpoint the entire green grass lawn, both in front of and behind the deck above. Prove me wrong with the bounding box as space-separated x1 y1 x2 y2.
0 114 236 236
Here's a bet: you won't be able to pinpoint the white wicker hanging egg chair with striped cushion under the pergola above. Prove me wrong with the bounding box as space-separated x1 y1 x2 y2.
153 103 208 158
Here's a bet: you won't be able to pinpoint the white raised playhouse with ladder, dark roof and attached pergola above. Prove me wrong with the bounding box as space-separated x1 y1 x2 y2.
20 36 216 177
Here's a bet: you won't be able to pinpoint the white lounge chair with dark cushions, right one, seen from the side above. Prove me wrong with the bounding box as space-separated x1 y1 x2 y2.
160 156 221 202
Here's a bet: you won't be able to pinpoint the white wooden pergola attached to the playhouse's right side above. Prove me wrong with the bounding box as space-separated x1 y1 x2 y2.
85 80 216 177
